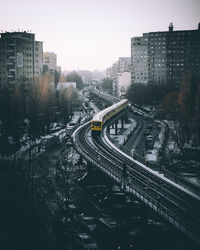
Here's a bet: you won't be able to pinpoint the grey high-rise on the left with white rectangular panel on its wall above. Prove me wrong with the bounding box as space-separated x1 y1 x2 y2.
0 32 43 84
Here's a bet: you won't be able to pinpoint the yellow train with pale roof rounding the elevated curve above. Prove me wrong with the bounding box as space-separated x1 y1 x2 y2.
91 99 128 132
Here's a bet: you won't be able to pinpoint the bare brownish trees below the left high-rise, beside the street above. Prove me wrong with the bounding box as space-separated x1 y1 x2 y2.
0 70 82 156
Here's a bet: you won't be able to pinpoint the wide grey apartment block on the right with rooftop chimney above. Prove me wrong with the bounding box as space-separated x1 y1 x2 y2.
131 23 200 86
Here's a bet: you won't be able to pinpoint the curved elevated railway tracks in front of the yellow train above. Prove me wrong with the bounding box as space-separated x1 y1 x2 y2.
74 118 200 243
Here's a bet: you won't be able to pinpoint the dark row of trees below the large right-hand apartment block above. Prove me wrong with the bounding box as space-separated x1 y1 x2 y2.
127 74 200 149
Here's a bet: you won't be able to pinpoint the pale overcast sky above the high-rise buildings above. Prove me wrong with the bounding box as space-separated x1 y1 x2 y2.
0 0 200 70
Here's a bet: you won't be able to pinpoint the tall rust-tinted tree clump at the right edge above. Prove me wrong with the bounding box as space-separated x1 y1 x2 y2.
160 74 200 149
